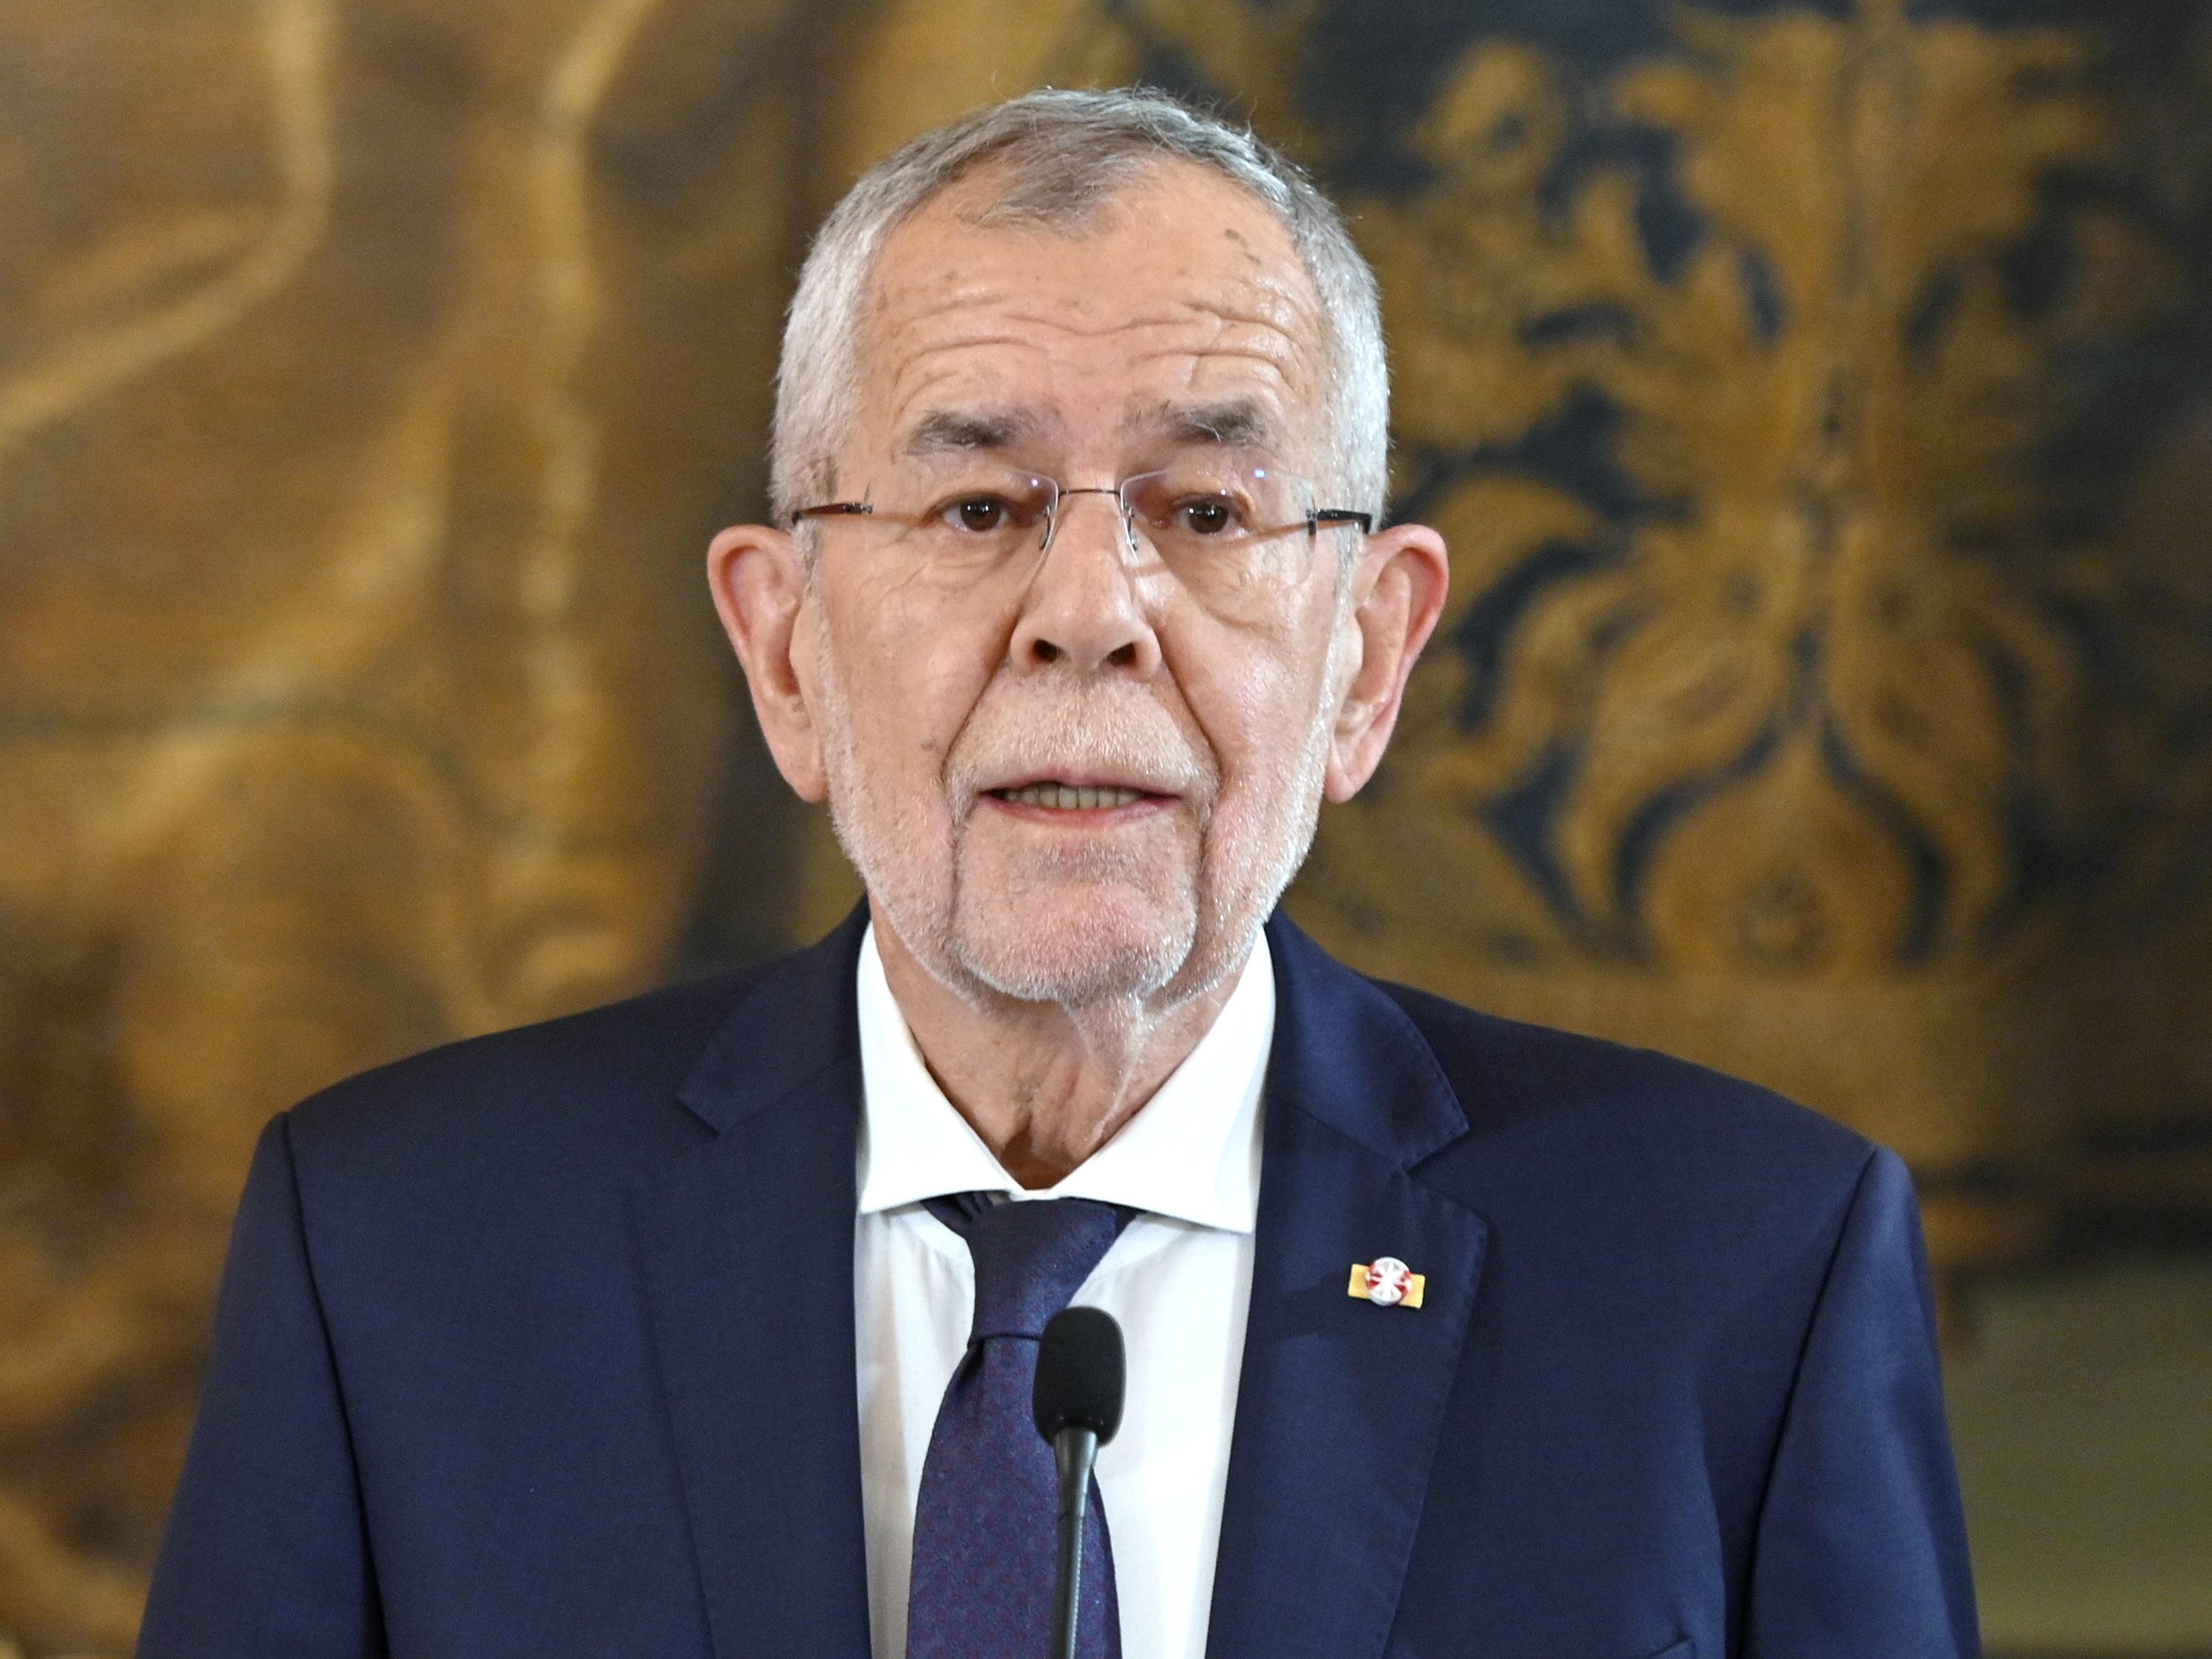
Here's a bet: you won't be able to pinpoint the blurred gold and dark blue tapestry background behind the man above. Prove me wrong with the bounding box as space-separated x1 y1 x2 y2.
0 0 2212 1657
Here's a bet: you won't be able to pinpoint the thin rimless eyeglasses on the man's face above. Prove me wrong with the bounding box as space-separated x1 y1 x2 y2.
792 456 1374 602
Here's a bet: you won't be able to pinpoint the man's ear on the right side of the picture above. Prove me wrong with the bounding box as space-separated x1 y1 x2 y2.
1325 525 1451 800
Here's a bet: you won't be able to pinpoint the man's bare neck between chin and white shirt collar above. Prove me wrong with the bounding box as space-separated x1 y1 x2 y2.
876 914 1243 1190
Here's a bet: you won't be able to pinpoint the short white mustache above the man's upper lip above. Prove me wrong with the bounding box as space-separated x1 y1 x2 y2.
945 692 1219 819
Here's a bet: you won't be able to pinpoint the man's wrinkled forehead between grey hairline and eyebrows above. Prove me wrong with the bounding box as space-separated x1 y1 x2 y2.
852 162 1332 469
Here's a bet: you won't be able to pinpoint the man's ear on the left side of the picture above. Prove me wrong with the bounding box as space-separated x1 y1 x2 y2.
706 525 830 800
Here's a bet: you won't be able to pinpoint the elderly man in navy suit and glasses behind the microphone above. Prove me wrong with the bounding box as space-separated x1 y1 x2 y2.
141 93 1975 1659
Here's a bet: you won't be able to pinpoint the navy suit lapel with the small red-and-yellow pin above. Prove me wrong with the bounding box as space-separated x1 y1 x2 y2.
1205 920 1487 1659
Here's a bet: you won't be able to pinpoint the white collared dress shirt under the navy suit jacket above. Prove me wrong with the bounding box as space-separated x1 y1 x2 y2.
854 929 1274 1659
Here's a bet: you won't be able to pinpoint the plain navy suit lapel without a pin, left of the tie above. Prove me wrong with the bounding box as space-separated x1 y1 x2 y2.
635 914 869 1659
